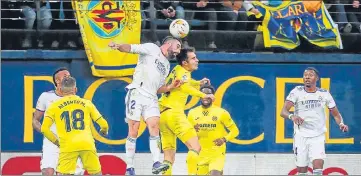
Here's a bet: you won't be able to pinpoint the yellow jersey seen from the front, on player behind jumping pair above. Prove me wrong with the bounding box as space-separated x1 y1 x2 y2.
188 105 239 150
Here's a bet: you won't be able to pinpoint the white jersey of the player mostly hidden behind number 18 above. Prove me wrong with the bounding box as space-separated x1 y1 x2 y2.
36 90 62 147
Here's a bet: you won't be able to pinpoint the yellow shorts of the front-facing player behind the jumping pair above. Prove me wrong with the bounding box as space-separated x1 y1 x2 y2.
197 150 226 175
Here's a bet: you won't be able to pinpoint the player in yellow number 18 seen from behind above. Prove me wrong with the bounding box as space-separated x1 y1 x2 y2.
41 77 108 175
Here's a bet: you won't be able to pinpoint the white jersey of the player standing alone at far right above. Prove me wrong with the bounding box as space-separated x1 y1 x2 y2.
286 86 336 137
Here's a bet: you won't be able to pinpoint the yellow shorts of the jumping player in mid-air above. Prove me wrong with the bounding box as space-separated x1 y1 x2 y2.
159 107 197 150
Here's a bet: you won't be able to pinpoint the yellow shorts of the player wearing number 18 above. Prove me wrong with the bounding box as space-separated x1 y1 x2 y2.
56 150 102 174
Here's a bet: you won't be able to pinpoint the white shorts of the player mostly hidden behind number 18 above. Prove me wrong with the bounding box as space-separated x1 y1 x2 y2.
40 139 85 175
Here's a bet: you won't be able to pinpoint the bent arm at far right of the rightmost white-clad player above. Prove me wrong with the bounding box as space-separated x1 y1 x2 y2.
326 92 348 132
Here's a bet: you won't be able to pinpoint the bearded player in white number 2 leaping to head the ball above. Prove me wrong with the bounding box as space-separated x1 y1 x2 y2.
109 37 181 175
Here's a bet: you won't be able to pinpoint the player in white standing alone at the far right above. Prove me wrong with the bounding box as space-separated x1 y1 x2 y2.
281 67 348 175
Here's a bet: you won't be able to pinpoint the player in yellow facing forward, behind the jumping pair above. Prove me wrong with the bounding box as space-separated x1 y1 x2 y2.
188 85 239 175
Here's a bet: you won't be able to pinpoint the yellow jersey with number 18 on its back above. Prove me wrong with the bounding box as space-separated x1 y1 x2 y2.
41 95 107 152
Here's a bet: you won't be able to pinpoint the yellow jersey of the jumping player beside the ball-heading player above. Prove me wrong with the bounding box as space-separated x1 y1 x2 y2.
159 65 206 111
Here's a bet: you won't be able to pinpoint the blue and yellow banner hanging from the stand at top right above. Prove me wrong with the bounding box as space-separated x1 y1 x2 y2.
252 1 342 50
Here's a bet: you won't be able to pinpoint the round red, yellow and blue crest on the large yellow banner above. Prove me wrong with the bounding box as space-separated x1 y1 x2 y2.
86 0 136 38
